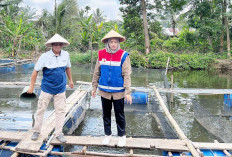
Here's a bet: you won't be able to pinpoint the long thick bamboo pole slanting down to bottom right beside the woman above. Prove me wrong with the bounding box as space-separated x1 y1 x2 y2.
152 85 200 157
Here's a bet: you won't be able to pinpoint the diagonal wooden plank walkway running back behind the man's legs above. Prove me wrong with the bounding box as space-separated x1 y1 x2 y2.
15 90 86 153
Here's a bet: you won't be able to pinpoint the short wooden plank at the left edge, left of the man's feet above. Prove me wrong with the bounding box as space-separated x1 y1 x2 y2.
0 131 26 142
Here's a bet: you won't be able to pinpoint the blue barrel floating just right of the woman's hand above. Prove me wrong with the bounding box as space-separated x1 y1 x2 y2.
131 91 148 105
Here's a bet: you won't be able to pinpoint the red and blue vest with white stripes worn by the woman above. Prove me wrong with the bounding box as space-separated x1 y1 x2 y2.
98 49 129 93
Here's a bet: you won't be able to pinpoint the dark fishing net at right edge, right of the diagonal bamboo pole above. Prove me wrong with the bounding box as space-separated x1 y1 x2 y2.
192 100 232 143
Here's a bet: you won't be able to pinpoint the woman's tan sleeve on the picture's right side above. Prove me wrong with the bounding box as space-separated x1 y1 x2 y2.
122 55 132 95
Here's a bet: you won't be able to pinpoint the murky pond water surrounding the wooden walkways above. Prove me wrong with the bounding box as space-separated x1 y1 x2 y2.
0 65 232 155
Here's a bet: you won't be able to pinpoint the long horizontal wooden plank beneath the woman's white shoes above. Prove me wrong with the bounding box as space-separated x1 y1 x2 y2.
51 136 188 152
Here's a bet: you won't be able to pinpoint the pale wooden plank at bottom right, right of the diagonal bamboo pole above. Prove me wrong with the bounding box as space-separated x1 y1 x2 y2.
193 142 232 150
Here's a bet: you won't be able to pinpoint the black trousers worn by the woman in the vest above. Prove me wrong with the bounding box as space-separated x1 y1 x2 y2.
101 97 126 136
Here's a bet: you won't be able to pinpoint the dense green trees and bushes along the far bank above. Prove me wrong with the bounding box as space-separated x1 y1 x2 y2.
0 0 232 69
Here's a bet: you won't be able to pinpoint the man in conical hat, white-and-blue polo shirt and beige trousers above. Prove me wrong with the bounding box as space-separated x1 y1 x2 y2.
27 34 74 143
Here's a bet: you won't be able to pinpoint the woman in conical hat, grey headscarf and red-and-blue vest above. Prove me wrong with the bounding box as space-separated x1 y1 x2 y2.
92 30 132 147
